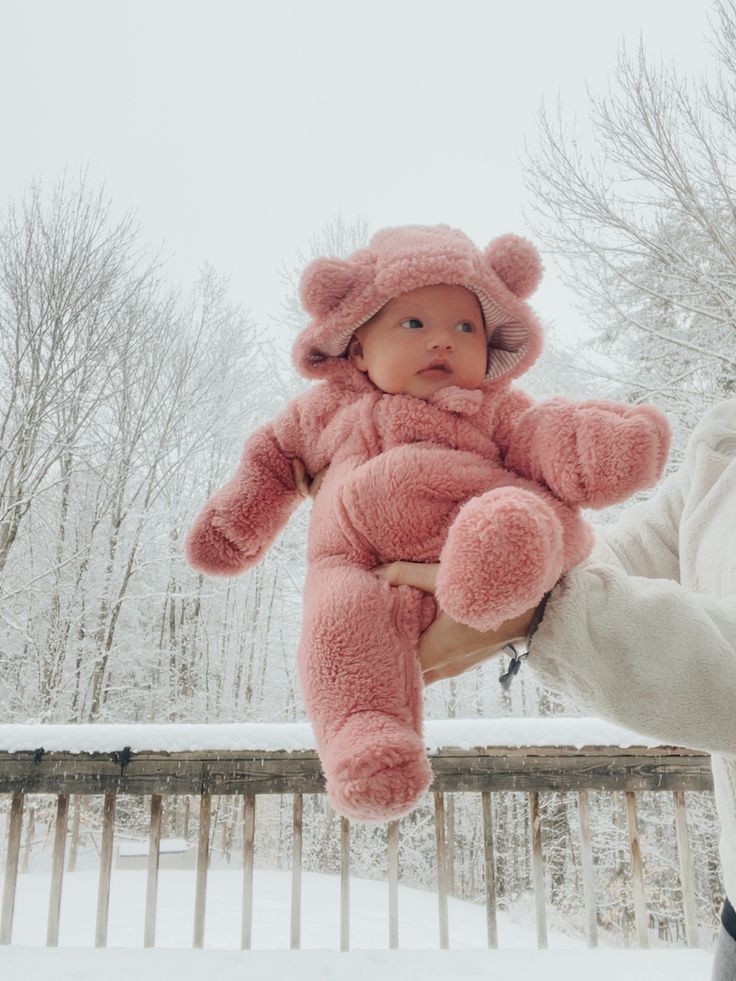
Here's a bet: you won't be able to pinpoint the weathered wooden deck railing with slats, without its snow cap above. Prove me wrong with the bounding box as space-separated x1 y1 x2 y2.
0 746 712 950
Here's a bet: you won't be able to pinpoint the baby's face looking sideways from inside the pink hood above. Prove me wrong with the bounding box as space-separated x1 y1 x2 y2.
350 285 488 399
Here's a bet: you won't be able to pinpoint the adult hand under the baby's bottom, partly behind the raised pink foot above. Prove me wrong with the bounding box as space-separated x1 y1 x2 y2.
374 562 534 685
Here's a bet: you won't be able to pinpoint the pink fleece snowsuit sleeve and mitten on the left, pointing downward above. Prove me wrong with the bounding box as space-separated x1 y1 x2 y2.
185 384 340 576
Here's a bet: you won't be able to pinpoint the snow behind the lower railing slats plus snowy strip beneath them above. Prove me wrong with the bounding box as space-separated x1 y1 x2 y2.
0 870 711 981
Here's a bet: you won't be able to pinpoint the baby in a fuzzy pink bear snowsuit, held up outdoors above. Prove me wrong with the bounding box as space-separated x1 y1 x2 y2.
186 226 669 821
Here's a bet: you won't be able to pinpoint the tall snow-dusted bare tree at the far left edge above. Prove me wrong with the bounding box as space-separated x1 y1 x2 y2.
0 178 160 572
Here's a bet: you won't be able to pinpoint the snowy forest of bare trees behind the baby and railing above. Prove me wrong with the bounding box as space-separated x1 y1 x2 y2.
0 0 736 943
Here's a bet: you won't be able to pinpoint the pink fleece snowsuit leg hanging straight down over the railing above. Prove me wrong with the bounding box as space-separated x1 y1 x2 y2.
298 559 434 821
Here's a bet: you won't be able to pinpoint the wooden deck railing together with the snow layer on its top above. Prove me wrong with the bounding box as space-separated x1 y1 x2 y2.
0 718 712 950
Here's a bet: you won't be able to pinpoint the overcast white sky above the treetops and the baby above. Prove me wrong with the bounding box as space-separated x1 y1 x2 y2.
0 0 713 340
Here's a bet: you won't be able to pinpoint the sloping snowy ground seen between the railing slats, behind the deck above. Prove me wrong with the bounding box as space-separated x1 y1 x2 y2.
7 869 585 950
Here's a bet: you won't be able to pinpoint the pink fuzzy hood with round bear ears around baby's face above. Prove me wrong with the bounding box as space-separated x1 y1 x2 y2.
293 225 542 383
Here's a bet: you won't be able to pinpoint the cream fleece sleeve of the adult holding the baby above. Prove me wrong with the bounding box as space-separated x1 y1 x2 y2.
529 469 736 754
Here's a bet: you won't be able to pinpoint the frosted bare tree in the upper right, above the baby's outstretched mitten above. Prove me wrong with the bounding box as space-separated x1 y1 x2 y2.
525 0 736 438
